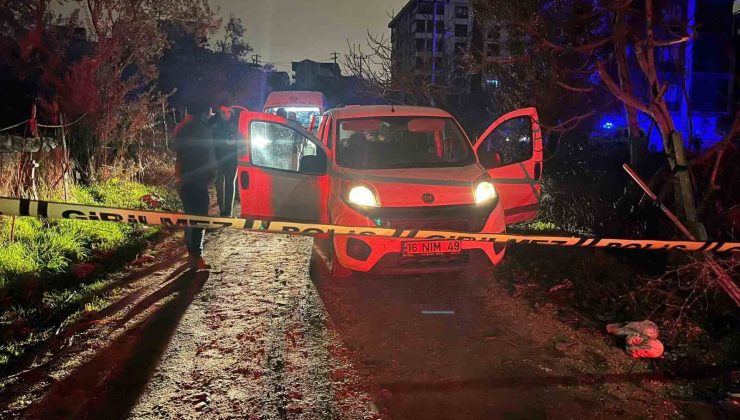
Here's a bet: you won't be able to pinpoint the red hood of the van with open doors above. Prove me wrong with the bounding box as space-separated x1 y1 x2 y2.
335 163 486 207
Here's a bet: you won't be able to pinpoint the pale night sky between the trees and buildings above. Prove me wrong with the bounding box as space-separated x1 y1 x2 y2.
217 0 407 70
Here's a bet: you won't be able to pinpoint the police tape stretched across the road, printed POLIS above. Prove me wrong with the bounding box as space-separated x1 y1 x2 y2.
0 198 740 252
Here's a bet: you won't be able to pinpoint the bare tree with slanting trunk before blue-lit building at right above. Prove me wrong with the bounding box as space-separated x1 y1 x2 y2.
476 0 704 237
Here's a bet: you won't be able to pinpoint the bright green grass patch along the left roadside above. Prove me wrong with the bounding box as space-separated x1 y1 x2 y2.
0 179 180 371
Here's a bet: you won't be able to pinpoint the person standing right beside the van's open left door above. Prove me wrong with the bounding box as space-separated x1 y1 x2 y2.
209 101 238 217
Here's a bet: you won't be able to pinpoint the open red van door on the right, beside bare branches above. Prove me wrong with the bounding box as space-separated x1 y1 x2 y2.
475 108 542 225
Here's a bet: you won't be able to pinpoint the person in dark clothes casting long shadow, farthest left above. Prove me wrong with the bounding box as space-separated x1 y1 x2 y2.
174 103 216 271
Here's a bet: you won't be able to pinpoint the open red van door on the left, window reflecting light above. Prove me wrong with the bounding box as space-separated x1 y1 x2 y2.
237 112 329 223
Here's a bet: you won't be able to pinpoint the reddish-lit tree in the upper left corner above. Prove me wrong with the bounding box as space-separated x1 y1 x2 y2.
0 0 218 176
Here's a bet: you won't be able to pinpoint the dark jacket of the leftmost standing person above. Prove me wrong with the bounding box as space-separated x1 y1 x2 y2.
174 115 216 187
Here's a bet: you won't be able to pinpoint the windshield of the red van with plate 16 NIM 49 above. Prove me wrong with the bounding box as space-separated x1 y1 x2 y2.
337 117 475 169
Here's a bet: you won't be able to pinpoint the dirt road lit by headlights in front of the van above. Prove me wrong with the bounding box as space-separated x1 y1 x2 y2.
0 232 677 419
